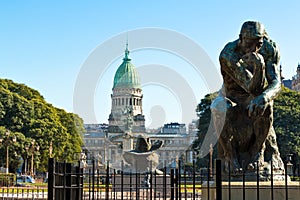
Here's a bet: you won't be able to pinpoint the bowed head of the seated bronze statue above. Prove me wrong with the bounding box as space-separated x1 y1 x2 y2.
240 21 266 53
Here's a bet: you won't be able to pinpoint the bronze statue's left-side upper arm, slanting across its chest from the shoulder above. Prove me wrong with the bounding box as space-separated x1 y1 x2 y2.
219 43 252 92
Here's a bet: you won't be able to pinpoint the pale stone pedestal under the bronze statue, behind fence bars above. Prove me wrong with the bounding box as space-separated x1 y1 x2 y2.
202 181 300 200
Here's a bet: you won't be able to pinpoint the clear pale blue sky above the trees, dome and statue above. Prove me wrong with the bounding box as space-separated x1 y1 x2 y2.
0 0 300 128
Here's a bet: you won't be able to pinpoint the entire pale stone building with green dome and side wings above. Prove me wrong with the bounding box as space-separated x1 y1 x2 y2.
84 45 197 169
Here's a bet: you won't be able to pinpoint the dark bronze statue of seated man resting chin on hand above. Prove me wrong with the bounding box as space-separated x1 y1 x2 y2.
211 21 284 172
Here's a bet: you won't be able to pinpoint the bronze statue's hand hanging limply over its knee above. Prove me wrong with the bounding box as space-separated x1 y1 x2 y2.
248 95 268 117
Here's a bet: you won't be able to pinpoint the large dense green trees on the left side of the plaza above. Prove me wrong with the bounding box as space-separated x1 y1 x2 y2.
0 79 84 172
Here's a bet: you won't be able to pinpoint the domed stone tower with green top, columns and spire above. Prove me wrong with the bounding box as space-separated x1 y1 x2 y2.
108 44 146 136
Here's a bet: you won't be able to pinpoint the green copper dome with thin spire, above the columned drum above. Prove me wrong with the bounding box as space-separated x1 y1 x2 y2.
113 45 141 88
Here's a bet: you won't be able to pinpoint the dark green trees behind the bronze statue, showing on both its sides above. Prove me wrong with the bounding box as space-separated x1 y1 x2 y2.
193 87 300 167
